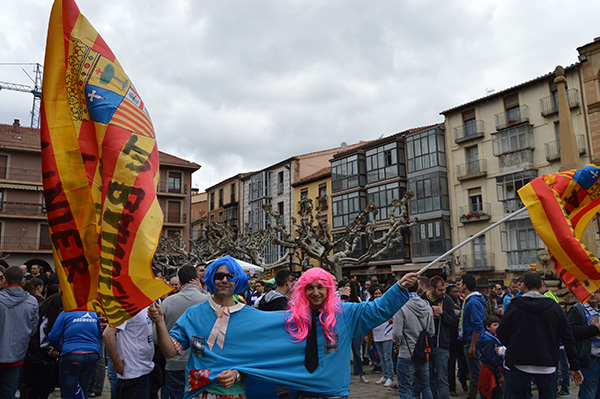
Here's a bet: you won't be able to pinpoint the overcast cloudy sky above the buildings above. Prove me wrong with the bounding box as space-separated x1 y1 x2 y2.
0 0 600 190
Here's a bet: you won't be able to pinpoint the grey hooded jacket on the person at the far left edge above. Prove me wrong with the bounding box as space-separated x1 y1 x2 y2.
0 286 39 363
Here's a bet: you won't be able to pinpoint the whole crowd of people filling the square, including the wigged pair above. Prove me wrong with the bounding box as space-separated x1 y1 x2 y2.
0 256 600 399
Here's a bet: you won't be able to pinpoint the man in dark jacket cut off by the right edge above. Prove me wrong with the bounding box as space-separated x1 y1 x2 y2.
567 291 600 398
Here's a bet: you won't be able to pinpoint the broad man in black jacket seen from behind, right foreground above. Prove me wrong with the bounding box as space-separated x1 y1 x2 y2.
497 270 583 399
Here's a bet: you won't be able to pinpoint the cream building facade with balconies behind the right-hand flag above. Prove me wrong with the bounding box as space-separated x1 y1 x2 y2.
441 66 589 279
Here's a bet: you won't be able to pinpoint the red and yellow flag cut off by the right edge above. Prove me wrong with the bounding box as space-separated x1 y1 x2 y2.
519 165 600 302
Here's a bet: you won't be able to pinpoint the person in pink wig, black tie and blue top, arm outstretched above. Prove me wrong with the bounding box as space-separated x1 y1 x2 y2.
286 267 419 399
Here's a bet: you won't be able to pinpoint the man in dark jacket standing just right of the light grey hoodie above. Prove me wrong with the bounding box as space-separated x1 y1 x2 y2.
421 276 458 399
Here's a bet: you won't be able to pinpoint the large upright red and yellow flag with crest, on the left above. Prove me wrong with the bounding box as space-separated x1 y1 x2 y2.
41 0 171 326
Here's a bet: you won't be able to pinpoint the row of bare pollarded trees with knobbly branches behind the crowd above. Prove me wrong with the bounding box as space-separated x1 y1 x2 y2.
154 190 415 278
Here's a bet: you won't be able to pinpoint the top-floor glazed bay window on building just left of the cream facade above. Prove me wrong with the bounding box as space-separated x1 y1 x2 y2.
406 129 446 173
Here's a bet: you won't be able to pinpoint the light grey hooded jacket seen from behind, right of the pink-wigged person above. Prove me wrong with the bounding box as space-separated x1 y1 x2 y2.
392 295 435 359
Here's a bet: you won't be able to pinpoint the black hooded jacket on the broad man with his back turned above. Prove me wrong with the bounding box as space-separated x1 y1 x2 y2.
496 291 579 370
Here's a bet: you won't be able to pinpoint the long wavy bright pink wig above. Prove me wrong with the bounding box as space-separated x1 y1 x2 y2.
285 267 342 342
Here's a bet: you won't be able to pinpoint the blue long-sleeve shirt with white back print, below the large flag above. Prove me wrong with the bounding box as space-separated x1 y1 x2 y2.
48 310 102 355
